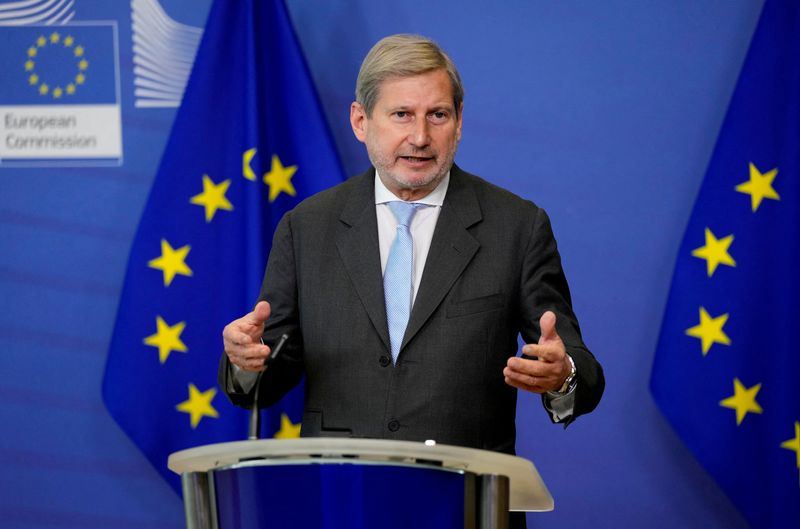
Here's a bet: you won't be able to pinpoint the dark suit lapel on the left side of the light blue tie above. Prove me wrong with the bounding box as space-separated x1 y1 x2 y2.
336 169 391 351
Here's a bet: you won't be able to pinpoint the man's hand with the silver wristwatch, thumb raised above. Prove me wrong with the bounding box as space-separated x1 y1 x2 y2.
503 310 572 393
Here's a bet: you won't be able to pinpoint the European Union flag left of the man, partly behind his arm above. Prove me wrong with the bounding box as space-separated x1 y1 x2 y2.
103 0 342 490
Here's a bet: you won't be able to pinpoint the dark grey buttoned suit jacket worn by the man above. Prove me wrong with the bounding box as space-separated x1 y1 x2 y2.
220 166 604 453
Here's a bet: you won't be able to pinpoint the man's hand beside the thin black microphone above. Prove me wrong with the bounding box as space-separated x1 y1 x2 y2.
222 301 271 371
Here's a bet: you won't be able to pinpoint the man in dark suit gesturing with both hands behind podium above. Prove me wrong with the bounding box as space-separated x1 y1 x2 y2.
220 35 604 453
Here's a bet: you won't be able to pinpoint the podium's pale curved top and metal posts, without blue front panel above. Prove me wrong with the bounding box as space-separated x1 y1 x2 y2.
168 438 554 529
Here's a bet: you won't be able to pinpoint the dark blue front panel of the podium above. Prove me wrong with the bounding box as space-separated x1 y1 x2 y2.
214 463 466 529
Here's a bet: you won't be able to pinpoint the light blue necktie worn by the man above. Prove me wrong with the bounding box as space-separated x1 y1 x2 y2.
383 201 422 363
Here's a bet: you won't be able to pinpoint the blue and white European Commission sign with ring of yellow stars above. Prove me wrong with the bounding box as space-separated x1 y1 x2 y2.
0 23 122 165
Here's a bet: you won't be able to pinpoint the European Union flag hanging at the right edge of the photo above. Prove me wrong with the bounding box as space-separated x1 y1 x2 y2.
651 0 800 528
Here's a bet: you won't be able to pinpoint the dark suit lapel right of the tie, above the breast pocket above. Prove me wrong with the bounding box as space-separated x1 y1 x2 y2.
404 165 483 354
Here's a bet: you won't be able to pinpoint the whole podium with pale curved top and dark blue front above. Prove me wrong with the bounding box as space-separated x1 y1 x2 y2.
168 438 553 529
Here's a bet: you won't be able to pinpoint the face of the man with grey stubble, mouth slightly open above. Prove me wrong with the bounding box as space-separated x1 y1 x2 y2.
350 70 462 200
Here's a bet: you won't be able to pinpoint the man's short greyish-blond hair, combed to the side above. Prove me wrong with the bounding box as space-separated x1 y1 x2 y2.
356 34 464 117
